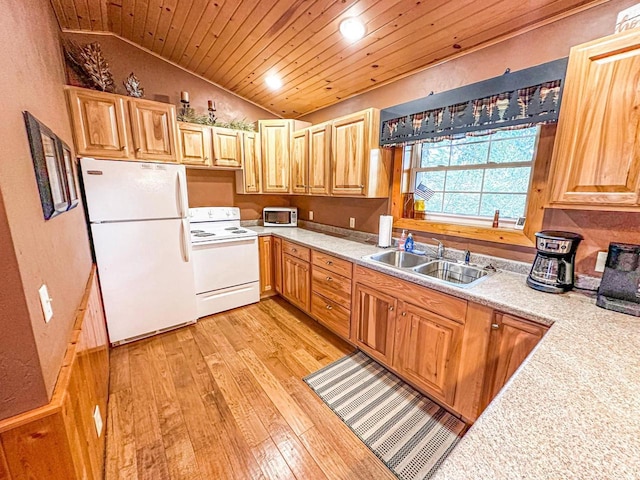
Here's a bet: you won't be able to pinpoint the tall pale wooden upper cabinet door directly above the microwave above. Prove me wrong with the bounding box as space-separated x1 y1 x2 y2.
258 120 291 193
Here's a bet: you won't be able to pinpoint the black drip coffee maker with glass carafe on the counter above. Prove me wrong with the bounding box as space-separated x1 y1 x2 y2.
527 230 582 293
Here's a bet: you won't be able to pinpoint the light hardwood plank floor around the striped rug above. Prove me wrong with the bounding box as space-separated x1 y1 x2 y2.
106 298 396 480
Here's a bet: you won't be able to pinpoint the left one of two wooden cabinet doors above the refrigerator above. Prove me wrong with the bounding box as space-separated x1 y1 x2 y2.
67 88 130 159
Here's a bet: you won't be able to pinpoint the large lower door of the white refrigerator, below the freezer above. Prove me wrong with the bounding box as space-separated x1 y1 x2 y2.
91 219 197 343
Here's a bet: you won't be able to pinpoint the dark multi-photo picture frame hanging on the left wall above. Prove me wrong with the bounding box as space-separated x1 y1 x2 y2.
23 112 79 220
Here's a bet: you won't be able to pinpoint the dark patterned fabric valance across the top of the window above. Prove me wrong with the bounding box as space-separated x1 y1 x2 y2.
380 58 567 147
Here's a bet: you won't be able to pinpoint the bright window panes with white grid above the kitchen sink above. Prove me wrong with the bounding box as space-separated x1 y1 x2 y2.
406 127 538 223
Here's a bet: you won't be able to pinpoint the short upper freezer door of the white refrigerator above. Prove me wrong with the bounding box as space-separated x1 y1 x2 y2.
80 158 188 222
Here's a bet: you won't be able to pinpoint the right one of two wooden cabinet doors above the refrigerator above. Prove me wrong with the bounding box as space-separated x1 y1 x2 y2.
129 99 177 162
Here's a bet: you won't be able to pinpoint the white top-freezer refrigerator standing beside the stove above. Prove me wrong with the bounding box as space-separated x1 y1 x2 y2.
80 158 197 345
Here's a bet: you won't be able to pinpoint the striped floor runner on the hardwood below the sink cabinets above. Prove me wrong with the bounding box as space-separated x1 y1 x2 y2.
304 351 465 480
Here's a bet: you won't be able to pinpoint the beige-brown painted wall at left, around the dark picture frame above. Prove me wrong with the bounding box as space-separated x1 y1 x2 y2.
0 0 91 418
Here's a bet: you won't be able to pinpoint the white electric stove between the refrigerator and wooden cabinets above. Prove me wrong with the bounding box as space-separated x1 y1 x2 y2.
189 207 260 318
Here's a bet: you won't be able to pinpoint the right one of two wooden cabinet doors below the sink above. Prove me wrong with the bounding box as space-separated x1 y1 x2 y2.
393 303 464 405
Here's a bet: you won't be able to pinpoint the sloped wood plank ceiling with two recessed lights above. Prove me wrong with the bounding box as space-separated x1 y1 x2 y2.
51 0 605 118
